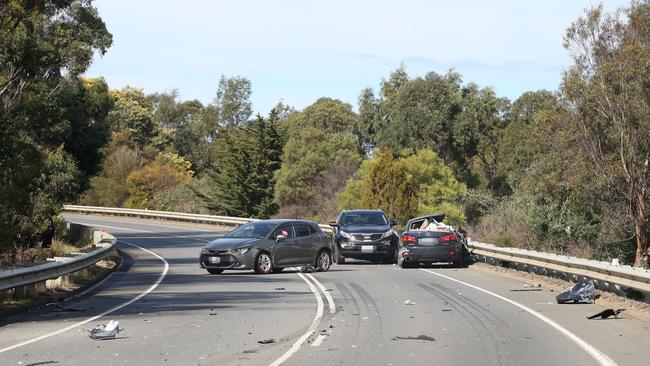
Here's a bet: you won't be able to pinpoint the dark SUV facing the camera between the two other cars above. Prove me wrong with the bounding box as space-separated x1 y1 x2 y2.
330 210 399 264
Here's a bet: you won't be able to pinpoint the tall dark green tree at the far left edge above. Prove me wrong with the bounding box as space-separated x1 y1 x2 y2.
0 0 112 252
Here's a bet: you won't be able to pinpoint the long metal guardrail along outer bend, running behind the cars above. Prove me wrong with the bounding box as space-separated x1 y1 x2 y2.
64 205 650 294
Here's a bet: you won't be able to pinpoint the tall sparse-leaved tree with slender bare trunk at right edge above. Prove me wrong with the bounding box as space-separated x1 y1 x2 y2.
561 1 650 266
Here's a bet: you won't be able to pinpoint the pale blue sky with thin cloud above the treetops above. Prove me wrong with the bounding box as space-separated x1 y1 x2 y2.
87 0 629 114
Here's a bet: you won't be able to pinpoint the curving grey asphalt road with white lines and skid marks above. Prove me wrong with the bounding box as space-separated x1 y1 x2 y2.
0 216 650 366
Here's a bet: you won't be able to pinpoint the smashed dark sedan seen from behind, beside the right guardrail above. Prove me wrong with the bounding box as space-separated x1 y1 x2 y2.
397 214 468 268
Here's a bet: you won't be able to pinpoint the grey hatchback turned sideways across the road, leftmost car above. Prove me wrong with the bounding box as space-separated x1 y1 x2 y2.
199 220 332 274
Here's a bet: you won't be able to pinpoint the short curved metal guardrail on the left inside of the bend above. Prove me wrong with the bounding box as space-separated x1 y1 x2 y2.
0 233 117 291
